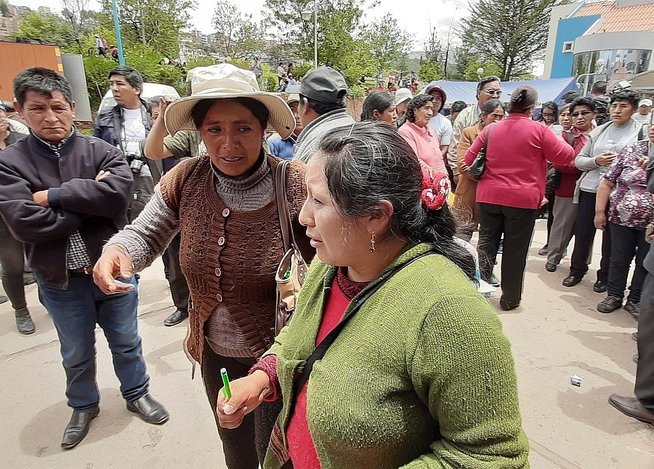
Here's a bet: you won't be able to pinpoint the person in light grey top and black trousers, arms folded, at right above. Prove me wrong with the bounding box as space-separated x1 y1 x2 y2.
563 91 642 293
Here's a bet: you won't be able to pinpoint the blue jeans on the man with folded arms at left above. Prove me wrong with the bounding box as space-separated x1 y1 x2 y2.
37 275 150 410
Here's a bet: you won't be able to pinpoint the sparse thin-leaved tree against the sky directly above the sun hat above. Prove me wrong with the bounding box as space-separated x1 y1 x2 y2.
213 0 265 59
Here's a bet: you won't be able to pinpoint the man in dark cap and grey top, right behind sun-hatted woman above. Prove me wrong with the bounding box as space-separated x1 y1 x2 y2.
293 67 354 163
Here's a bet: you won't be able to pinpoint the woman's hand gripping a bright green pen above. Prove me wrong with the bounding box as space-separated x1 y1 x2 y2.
216 370 271 428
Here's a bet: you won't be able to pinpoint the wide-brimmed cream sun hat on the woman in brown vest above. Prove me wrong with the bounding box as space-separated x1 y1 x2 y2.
164 64 295 138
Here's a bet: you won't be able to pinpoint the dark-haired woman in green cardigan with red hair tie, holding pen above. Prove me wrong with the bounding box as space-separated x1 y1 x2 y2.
217 123 528 469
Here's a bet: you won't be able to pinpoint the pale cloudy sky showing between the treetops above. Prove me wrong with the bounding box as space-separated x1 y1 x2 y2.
9 0 466 50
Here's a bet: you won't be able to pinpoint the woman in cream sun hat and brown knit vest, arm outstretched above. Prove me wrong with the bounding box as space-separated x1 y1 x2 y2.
94 64 312 469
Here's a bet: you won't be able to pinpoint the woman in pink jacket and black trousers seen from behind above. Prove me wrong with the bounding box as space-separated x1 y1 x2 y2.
465 86 574 311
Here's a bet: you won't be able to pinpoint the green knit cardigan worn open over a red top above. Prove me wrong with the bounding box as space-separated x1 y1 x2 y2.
264 244 529 469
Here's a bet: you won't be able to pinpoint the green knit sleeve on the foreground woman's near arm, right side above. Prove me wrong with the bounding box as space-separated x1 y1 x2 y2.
405 295 529 468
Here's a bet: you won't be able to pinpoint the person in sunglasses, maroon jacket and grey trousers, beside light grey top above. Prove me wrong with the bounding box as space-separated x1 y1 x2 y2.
545 98 595 272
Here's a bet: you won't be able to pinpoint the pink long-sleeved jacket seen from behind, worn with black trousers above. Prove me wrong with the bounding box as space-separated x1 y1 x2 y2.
465 114 575 209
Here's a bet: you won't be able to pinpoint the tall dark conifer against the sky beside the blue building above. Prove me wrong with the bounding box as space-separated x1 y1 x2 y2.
461 0 567 80
